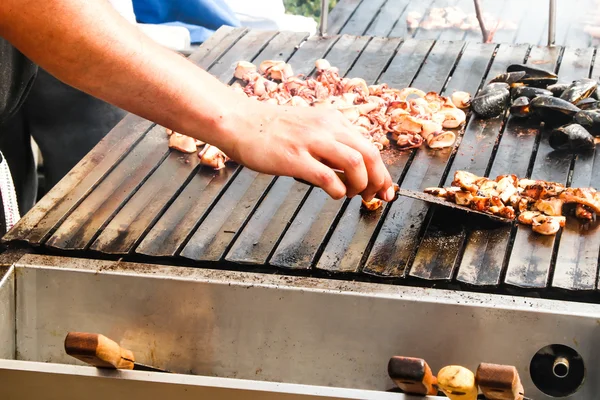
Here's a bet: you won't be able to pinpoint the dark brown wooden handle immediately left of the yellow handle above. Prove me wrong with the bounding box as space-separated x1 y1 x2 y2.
388 356 438 395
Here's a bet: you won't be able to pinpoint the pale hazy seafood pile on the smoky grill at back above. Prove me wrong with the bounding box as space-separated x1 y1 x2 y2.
406 7 518 31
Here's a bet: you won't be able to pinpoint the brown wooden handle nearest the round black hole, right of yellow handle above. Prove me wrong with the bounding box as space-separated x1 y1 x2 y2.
475 363 525 400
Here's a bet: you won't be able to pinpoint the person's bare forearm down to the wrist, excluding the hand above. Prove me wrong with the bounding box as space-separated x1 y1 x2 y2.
0 0 248 152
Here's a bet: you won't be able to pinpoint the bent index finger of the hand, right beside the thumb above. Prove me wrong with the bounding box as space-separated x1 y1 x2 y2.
310 140 369 197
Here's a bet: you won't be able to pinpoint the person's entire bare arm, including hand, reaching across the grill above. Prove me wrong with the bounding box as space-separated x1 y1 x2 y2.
0 0 393 200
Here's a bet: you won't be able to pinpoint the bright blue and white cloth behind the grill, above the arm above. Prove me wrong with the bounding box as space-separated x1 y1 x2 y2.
133 0 241 43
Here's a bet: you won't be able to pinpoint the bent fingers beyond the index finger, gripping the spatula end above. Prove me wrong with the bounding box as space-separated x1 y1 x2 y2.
336 122 395 201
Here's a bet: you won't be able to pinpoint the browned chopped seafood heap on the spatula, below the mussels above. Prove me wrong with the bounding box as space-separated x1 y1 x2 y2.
425 171 600 235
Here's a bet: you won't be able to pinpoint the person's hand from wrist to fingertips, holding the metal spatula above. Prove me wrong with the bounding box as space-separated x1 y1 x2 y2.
218 100 395 201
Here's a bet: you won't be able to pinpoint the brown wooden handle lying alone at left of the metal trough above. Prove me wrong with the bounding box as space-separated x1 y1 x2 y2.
65 332 135 369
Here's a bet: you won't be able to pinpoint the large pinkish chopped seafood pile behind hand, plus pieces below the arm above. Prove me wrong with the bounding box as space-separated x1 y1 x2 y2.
167 59 471 169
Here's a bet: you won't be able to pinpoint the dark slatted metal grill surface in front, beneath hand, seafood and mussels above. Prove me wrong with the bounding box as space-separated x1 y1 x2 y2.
4 26 600 302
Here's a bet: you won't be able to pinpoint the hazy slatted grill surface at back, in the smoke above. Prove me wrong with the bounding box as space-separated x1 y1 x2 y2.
327 0 600 47
